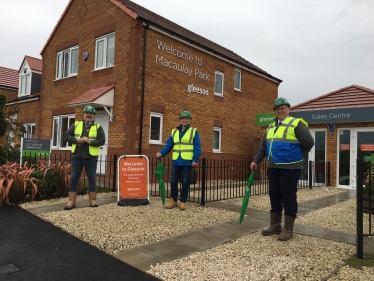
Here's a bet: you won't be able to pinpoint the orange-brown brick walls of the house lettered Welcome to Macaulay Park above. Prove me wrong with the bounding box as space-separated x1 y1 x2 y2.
37 0 278 159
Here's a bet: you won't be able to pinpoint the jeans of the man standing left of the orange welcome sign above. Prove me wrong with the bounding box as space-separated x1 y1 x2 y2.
69 157 97 192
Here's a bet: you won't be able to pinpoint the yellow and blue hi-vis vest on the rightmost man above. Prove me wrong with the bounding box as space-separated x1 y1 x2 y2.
266 116 308 164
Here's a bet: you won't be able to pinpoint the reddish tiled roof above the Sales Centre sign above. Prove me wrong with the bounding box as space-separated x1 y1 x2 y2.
291 85 374 111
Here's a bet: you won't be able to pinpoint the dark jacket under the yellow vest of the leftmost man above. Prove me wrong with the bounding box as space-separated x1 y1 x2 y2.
64 121 105 158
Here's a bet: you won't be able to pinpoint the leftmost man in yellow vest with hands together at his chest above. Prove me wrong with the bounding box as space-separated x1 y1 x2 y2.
64 105 105 210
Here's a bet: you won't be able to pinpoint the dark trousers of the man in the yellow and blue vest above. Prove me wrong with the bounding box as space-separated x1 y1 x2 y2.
267 168 301 217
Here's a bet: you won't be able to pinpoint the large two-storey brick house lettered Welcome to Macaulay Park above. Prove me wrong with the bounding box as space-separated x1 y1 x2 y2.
36 0 282 167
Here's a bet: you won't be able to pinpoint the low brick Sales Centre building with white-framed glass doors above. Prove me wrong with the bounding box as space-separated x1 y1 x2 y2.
291 85 374 188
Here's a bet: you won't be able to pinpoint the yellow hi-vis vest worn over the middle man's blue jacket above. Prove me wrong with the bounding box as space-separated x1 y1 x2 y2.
171 127 196 160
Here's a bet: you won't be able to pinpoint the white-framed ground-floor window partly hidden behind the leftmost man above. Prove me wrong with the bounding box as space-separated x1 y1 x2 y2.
52 115 75 148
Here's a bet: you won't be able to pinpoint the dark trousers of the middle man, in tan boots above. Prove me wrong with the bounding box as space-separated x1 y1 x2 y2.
170 166 191 202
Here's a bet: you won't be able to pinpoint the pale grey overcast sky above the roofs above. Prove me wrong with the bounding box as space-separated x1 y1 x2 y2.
0 0 374 105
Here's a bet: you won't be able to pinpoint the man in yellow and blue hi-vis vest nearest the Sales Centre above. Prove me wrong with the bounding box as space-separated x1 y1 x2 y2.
251 98 314 241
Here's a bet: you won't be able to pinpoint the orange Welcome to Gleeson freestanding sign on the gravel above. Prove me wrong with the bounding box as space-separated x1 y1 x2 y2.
117 155 149 206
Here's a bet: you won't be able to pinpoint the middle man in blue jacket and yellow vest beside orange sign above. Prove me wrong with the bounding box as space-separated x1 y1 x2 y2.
156 111 201 210
